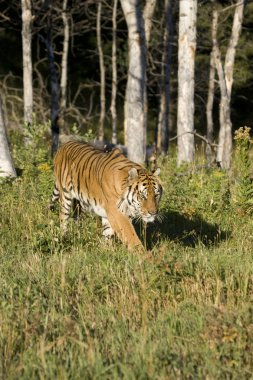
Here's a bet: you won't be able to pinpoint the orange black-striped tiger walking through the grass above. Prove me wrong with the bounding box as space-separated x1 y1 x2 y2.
51 141 163 250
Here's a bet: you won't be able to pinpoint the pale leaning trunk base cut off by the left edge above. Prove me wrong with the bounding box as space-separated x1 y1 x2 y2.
0 97 17 177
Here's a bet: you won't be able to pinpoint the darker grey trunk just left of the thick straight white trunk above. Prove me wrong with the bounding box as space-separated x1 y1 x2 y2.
157 0 174 156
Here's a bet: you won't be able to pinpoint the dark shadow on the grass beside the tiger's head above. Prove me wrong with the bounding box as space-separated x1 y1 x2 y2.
136 211 231 249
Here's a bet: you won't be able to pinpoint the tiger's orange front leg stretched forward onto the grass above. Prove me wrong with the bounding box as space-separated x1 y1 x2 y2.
107 207 145 252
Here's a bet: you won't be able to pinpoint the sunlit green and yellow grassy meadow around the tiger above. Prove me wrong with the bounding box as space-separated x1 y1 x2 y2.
0 128 253 380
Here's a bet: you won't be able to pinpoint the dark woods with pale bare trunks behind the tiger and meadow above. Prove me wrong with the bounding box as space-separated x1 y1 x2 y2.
0 0 253 168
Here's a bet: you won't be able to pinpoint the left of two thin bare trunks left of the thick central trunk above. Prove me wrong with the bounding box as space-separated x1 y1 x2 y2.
97 0 105 141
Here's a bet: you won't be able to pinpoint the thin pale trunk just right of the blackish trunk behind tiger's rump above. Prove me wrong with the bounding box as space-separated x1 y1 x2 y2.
59 0 69 133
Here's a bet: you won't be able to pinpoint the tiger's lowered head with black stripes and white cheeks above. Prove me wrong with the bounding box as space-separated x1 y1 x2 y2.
120 167 163 223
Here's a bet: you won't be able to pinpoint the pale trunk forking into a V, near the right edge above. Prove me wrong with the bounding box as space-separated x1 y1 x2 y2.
212 0 245 169
